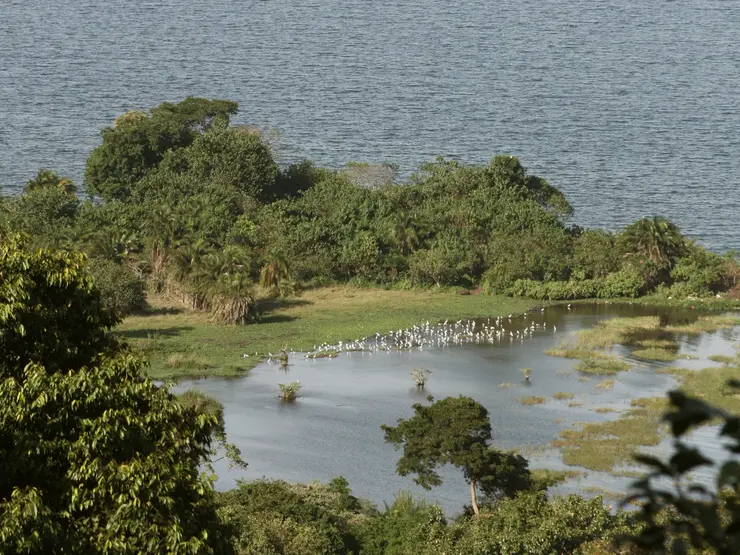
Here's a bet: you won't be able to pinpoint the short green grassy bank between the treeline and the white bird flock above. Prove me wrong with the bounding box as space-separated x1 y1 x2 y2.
115 287 542 379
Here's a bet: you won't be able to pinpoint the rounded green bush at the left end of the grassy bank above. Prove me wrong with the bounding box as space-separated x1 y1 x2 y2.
88 258 146 316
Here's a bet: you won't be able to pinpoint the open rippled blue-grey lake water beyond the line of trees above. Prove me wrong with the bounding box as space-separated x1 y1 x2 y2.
0 0 740 251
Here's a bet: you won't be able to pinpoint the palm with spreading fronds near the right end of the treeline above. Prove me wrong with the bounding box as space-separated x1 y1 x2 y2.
617 216 686 268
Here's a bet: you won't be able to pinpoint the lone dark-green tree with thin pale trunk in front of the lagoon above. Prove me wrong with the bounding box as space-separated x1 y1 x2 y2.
381 396 529 515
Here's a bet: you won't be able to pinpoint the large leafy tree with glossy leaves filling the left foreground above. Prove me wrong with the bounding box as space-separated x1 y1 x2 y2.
0 232 231 554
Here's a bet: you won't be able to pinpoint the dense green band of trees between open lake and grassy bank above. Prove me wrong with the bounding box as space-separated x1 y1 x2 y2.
1 98 740 322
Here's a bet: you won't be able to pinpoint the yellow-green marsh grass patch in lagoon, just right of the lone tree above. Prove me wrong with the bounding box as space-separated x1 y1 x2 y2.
552 397 668 472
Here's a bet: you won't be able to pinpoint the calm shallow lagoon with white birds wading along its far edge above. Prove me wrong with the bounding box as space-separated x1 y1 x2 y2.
177 304 740 513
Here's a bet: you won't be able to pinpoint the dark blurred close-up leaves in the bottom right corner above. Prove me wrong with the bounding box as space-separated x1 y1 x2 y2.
623 380 740 555
